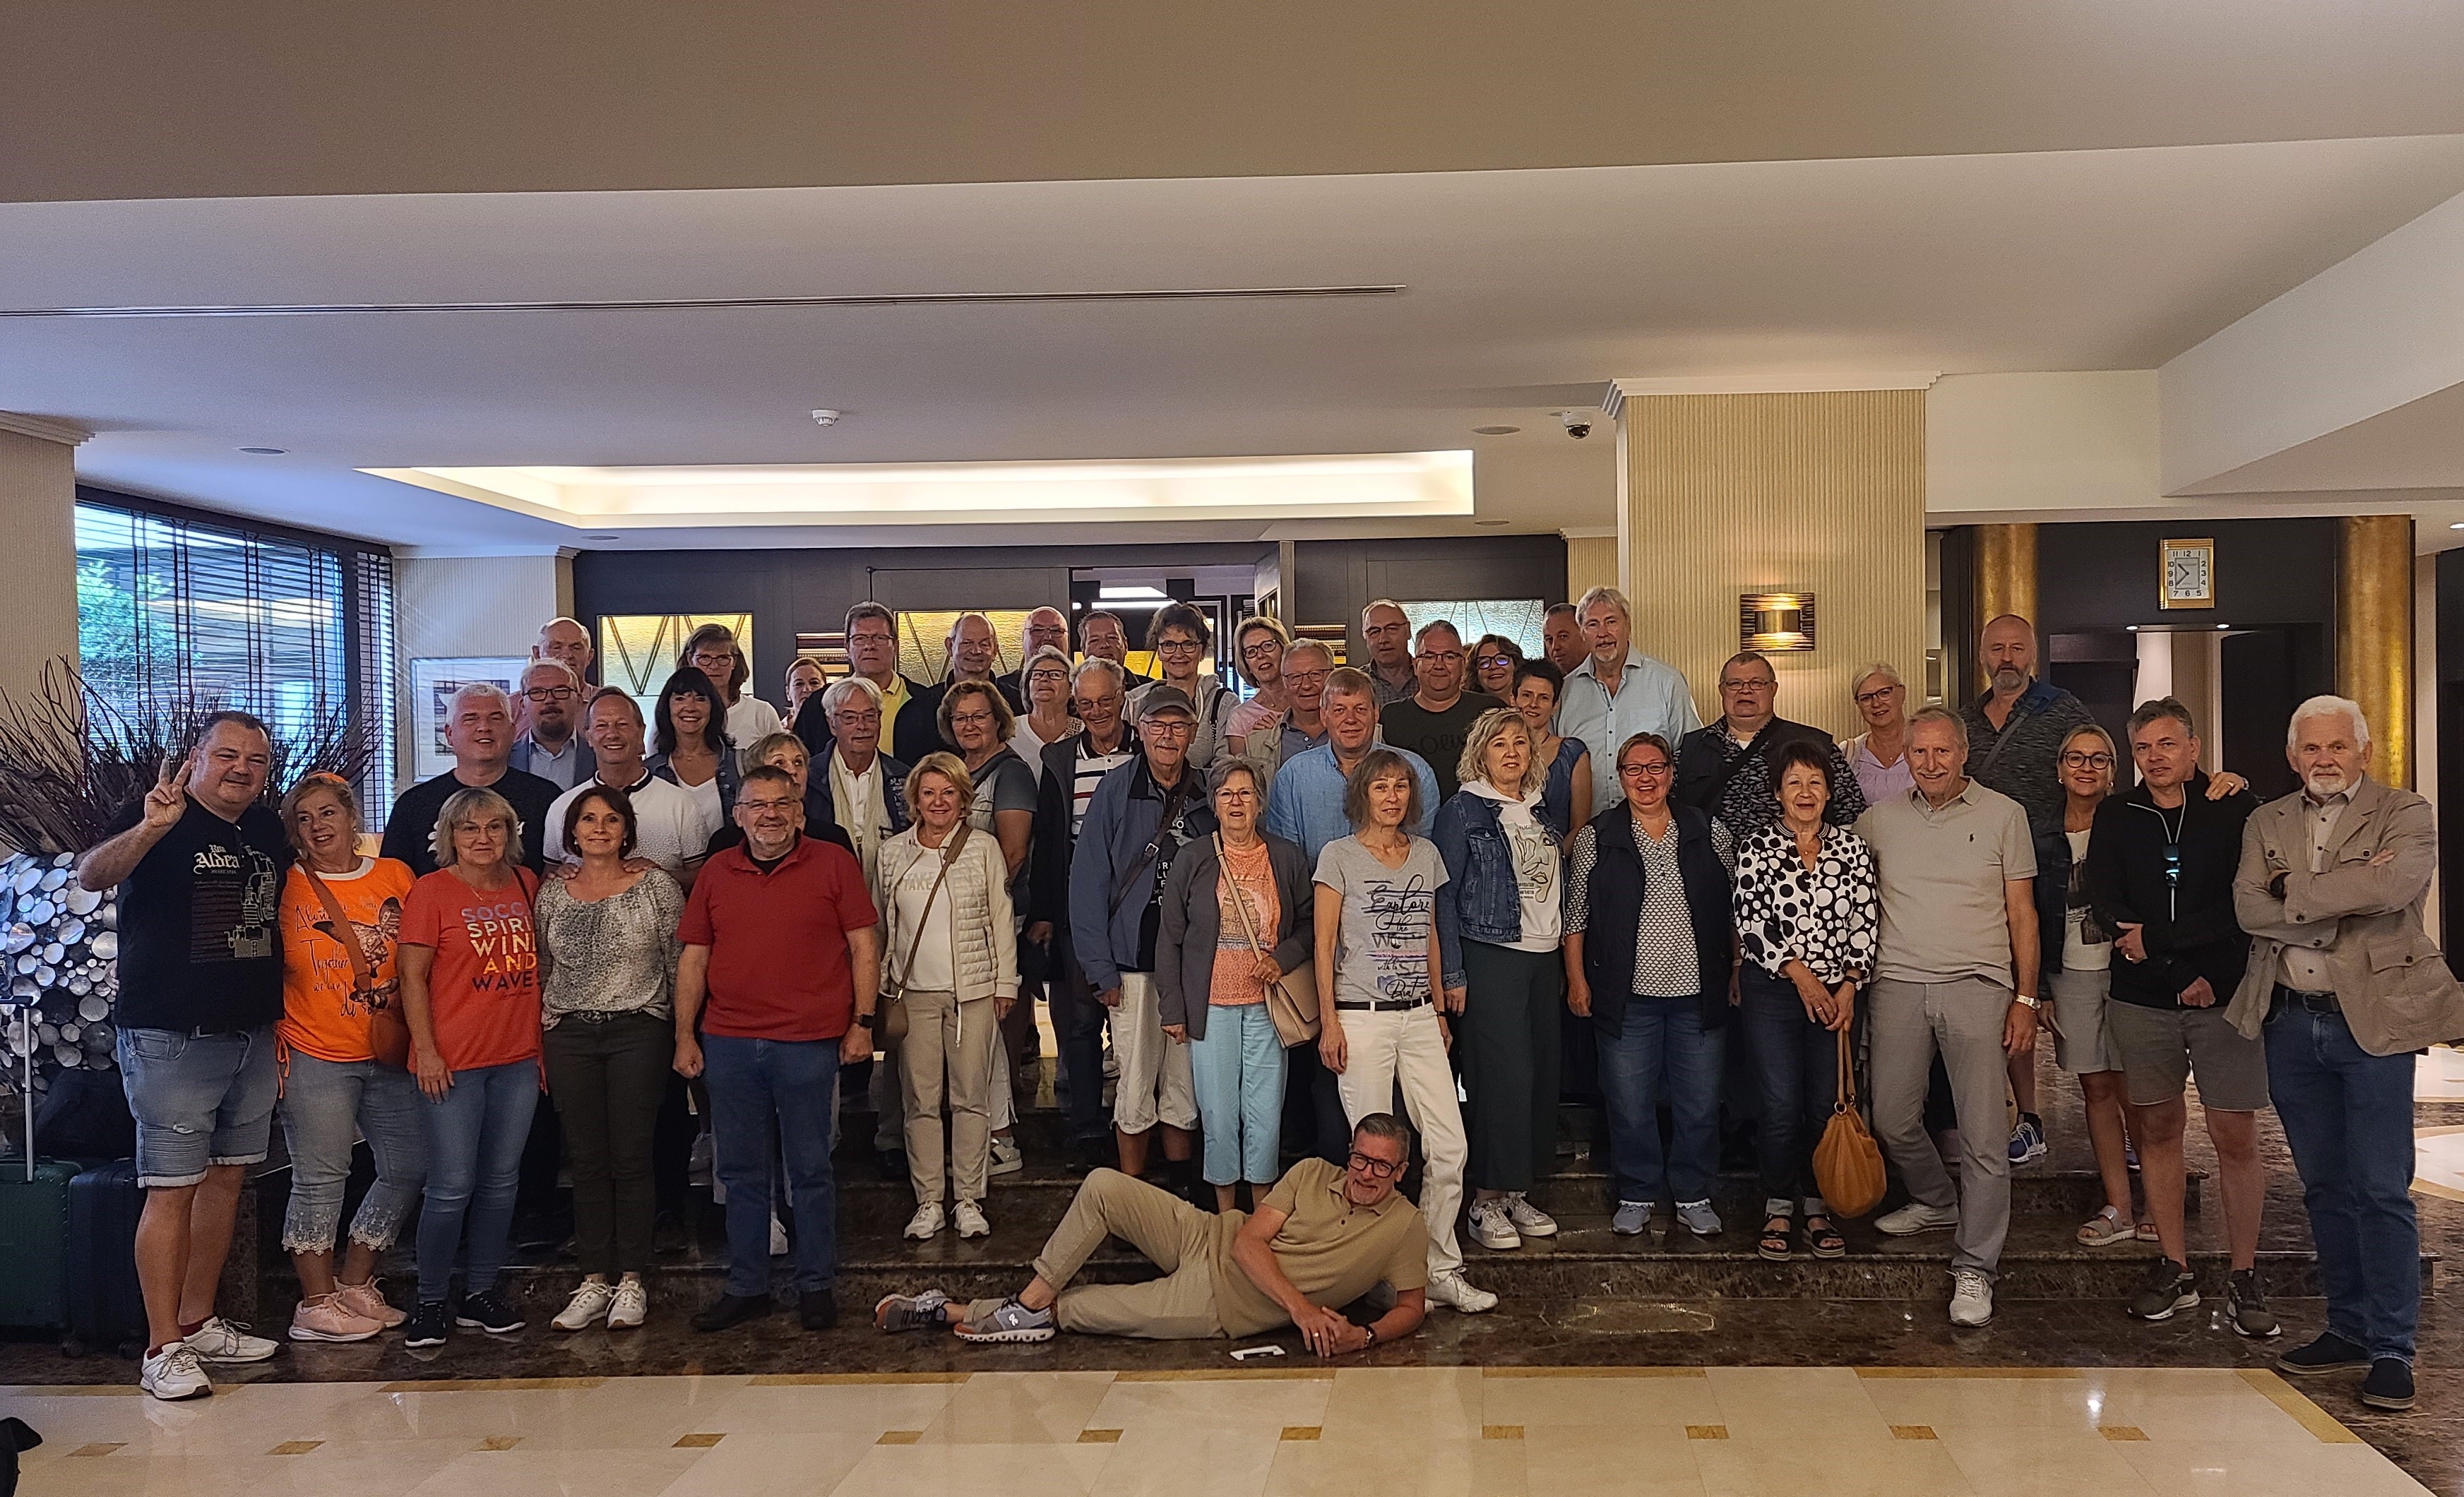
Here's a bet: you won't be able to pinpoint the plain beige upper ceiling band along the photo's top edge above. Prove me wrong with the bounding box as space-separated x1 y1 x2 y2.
14 0 2464 202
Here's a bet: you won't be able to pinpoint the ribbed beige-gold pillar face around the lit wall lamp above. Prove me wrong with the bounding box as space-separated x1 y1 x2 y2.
1617 389 1924 736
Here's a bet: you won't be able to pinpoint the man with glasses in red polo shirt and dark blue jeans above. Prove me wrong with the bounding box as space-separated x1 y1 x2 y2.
675 765 882 1330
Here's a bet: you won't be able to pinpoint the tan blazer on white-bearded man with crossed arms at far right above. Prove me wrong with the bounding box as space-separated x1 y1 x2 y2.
2225 778 2464 1056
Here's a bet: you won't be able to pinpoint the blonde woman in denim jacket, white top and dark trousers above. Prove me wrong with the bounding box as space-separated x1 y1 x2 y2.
1432 707 1565 1248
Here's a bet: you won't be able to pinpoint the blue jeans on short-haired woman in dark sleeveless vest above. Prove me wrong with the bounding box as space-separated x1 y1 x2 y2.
1594 995 1727 1202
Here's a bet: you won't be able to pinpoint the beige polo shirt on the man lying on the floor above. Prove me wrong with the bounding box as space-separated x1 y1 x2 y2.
1215 1159 1429 1337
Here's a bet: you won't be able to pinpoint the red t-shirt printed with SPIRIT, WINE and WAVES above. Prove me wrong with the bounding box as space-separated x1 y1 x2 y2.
402 866 540 1071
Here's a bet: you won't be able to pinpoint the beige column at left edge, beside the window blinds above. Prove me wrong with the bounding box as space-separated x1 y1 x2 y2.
0 411 89 699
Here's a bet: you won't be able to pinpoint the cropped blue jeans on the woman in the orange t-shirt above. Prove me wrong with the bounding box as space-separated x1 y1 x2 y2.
281 1051 429 1253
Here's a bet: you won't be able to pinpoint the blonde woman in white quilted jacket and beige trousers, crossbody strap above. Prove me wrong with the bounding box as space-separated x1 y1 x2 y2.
872 753 1018 1241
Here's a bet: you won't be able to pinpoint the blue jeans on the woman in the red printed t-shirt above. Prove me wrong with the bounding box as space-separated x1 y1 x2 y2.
419 1061 540 1305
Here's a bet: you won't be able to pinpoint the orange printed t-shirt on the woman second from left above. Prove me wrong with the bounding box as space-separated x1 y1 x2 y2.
273 857 412 1061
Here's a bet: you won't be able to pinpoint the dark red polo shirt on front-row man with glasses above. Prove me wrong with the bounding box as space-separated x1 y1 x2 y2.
675 837 880 1039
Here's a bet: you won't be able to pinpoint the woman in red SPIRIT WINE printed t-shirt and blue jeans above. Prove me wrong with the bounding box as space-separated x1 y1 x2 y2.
402 788 540 1347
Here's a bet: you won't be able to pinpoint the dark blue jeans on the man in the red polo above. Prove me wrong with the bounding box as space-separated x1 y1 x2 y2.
702 1034 838 1300
